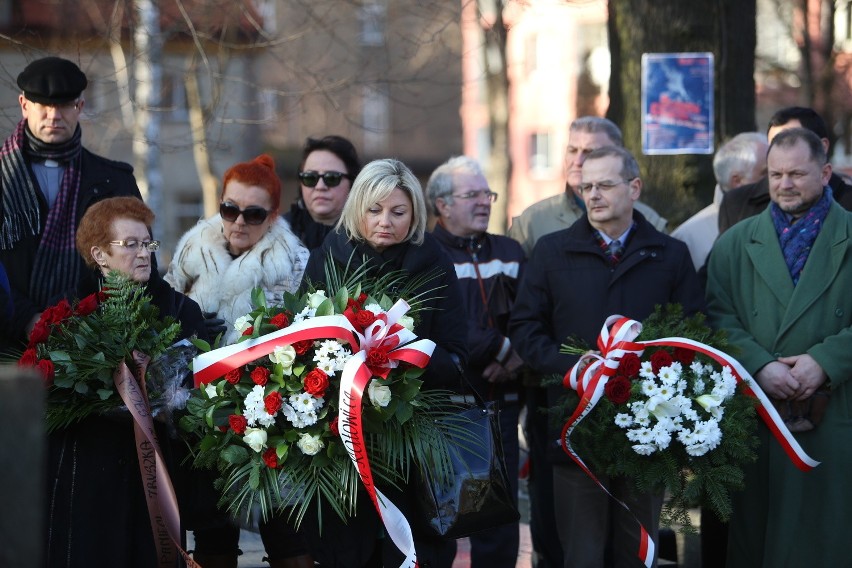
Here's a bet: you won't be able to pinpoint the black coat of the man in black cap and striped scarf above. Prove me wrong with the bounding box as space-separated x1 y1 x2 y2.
0 148 143 343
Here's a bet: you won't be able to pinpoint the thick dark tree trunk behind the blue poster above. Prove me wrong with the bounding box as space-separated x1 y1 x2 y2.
607 0 756 226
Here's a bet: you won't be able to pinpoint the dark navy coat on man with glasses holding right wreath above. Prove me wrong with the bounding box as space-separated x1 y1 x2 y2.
509 211 704 460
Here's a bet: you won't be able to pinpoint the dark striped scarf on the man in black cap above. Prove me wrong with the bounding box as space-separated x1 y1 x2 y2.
0 120 83 306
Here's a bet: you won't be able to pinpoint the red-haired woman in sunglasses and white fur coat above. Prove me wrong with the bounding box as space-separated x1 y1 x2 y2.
166 154 308 344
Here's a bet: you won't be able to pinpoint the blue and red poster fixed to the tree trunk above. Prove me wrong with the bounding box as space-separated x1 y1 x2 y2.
642 53 713 155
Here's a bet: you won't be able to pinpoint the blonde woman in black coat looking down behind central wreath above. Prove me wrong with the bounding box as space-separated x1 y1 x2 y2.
302 159 468 568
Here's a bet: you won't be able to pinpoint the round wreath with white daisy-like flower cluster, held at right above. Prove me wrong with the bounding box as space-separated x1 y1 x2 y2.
561 305 757 530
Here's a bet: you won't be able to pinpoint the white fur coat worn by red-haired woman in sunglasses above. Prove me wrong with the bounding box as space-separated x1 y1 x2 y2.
166 215 309 345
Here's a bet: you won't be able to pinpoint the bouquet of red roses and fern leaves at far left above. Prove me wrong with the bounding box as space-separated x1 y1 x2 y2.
18 272 180 432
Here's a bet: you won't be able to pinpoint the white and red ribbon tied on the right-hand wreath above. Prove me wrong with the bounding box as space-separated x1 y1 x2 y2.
561 315 820 566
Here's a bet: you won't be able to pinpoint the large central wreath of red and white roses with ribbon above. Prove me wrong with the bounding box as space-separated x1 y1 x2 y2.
180 264 470 524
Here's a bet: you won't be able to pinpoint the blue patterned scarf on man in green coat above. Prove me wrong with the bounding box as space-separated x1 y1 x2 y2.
769 186 833 286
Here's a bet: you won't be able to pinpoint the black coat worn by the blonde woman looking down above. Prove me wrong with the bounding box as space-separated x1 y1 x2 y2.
302 231 468 390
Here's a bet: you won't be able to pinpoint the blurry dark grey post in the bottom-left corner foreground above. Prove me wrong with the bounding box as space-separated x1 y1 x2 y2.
0 365 47 568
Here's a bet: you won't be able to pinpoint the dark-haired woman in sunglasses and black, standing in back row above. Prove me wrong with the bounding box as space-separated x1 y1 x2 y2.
284 136 361 250
